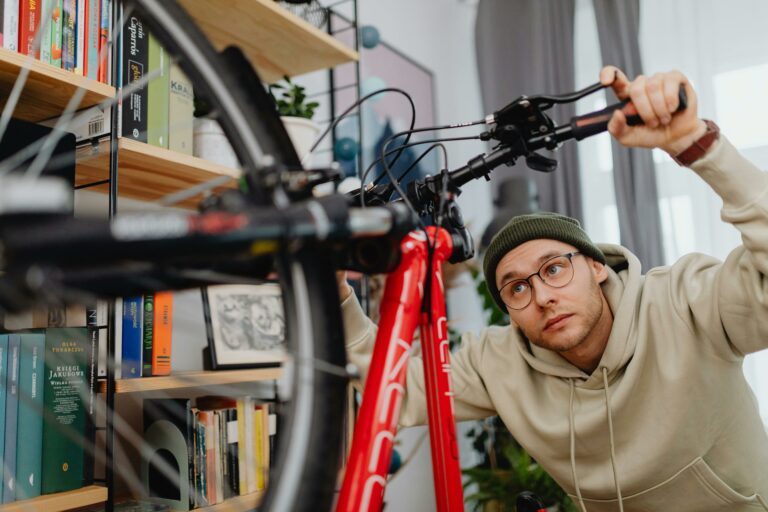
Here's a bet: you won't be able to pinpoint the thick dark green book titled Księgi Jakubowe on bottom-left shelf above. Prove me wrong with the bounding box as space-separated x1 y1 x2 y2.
42 327 89 494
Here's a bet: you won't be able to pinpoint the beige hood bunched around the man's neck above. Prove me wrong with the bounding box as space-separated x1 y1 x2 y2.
514 244 643 389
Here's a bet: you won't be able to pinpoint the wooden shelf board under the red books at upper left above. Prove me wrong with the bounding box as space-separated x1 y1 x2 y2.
0 48 115 122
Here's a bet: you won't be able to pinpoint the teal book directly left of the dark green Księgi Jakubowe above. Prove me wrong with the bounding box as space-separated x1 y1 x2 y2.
16 334 45 500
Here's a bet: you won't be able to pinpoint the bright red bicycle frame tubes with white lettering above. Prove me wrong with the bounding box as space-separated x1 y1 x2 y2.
336 227 464 512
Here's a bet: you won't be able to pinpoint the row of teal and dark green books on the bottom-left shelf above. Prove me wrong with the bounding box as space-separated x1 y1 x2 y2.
0 327 98 503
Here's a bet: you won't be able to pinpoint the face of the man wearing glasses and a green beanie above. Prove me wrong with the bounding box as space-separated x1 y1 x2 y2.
496 239 608 352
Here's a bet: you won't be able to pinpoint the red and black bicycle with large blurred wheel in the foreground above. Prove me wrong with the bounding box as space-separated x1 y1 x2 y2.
0 0 684 511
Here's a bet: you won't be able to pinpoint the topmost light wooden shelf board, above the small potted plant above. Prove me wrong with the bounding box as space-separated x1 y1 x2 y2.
179 0 358 83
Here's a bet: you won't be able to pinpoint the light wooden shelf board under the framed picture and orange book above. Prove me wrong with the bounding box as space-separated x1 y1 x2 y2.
99 368 282 396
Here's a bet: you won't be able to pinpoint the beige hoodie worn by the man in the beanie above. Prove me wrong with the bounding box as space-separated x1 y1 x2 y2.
342 139 768 512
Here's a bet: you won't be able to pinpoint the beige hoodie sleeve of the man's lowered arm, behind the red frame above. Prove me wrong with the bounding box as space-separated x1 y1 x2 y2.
341 293 496 427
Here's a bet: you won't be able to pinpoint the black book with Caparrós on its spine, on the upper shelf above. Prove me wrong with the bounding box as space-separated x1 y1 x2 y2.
121 15 149 142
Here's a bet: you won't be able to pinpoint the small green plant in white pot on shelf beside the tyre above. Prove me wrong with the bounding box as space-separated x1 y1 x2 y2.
269 76 320 158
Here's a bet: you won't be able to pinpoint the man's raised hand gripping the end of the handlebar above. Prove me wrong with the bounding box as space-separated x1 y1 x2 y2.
600 66 707 156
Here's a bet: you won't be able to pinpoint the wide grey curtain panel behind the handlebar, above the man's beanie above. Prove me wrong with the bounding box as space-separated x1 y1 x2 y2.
475 0 582 219
